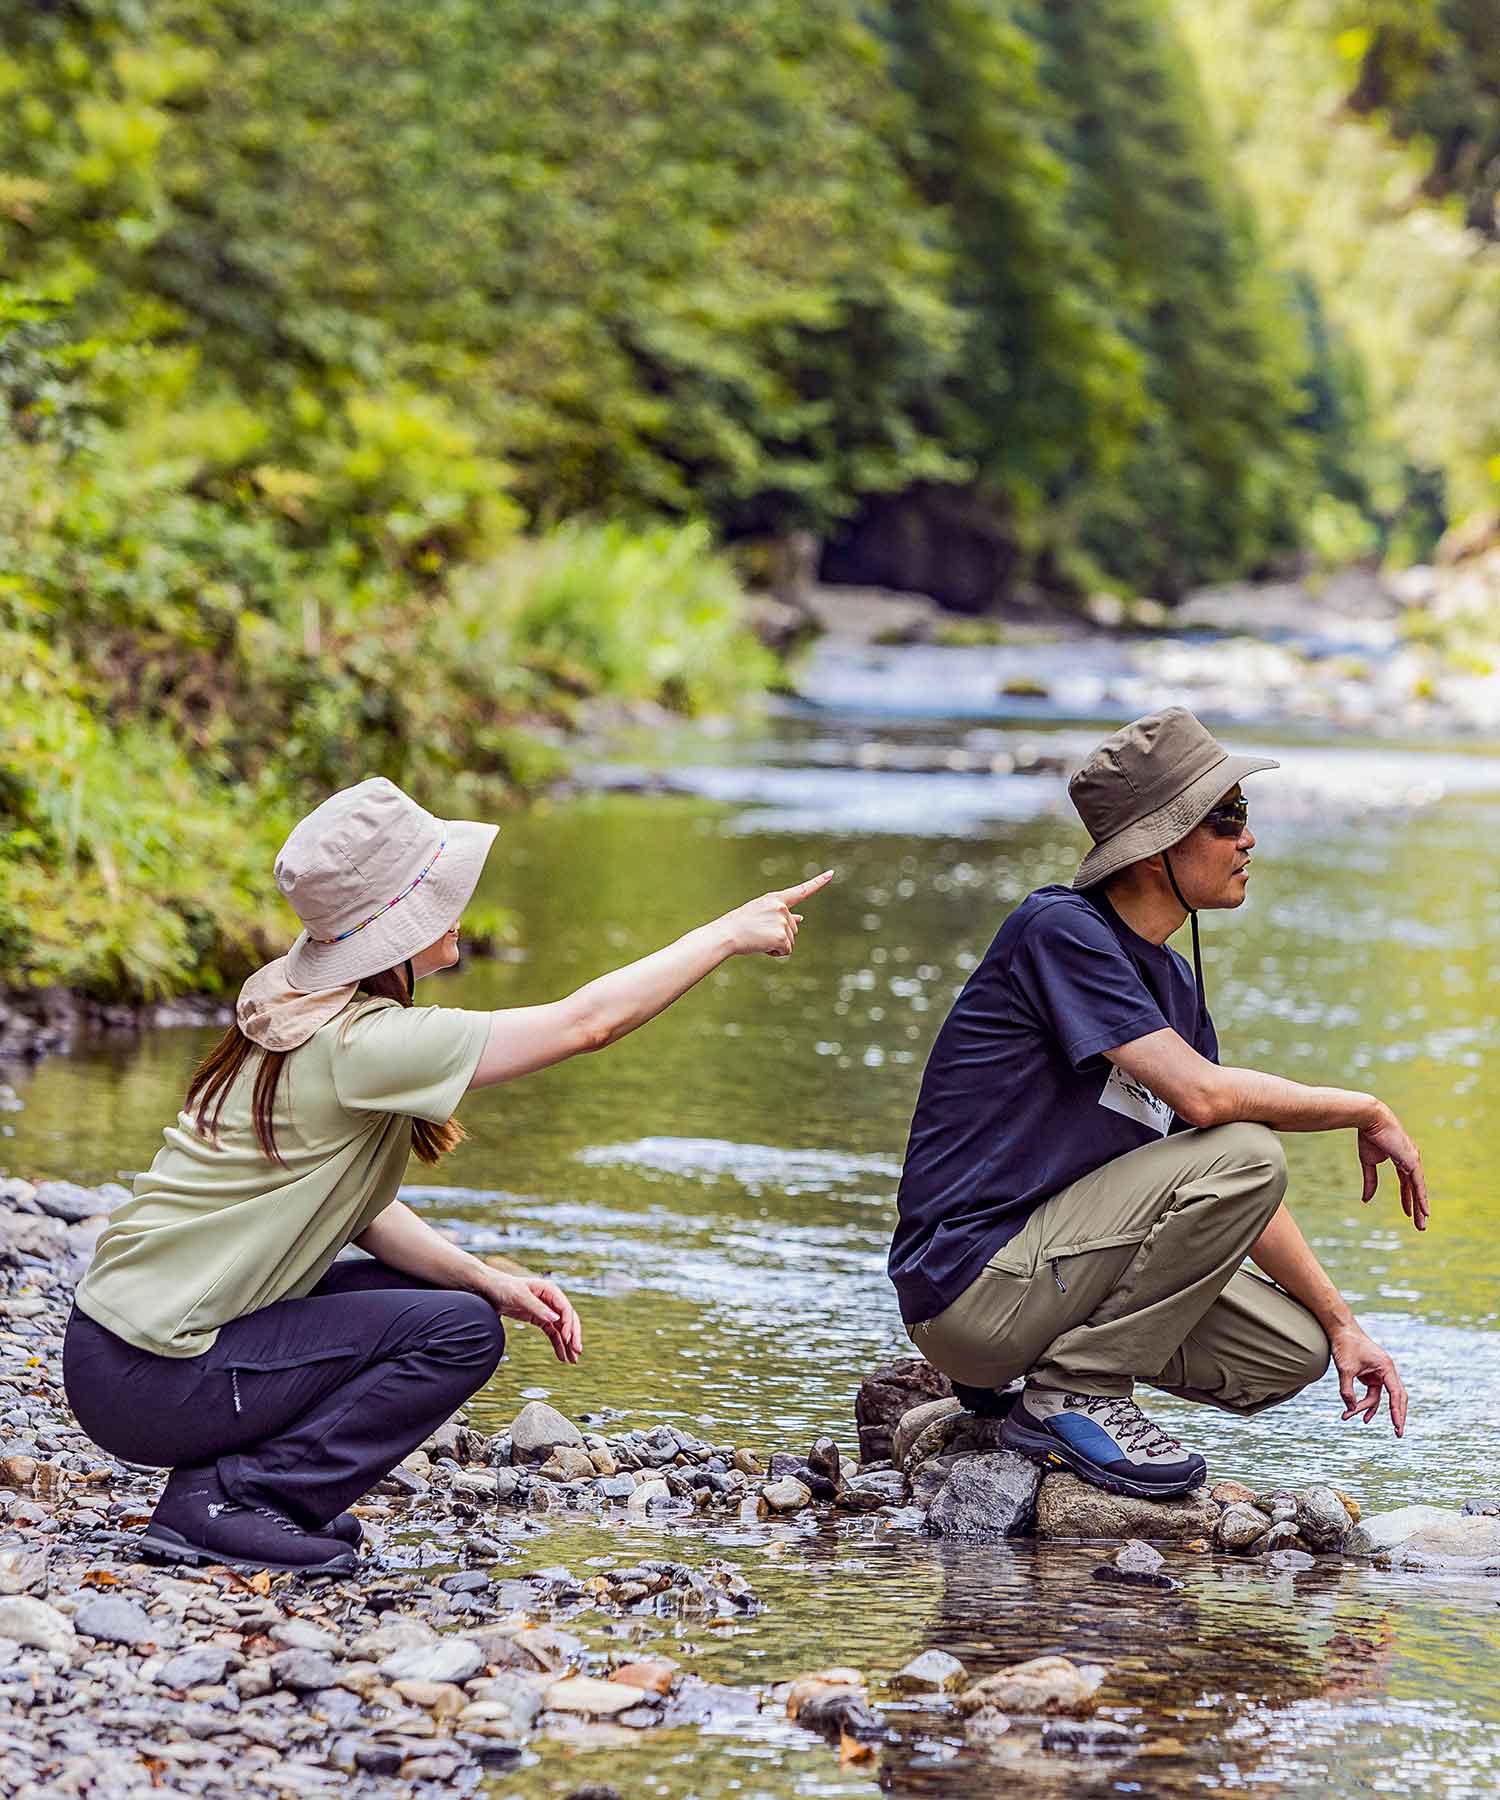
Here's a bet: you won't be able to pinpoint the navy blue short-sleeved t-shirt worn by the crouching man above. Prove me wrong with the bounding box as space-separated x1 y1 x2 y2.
890 887 1219 1325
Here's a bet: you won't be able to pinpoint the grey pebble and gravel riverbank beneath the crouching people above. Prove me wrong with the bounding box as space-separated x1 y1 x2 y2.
0 1179 1500 1800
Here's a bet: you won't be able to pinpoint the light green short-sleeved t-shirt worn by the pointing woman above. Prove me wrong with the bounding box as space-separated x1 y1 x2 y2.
76 995 490 1357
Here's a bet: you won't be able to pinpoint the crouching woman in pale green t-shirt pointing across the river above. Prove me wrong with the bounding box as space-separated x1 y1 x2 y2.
63 778 830 1575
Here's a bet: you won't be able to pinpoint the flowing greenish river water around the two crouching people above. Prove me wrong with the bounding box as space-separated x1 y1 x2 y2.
0 652 1500 1796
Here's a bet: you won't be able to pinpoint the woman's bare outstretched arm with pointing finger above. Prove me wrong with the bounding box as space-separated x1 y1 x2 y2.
470 869 834 1087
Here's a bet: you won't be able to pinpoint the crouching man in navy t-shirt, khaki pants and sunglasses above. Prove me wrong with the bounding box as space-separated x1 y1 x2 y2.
890 707 1428 1498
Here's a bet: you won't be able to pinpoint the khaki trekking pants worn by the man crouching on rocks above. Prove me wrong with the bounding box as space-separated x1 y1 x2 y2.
909 1123 1329 1413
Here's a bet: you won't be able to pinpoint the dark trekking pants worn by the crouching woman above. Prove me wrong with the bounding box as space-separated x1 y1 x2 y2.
63 1262 506 1530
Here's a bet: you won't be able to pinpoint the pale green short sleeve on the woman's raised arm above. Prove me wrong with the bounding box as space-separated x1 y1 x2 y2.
331 1003 490 1125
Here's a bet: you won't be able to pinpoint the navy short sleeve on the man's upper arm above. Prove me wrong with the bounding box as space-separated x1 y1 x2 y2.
1010 905 1167 1069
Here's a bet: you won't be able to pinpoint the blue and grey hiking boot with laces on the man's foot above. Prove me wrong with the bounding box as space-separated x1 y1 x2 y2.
999 1386 1208 1499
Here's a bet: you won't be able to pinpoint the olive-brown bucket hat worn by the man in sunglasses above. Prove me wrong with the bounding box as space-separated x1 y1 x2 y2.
1068 706 1280 887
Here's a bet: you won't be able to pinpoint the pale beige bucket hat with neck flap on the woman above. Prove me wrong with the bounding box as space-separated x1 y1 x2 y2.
236 776 499 1049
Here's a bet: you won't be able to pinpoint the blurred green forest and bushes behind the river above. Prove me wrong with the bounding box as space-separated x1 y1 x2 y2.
0 0 1500 997
